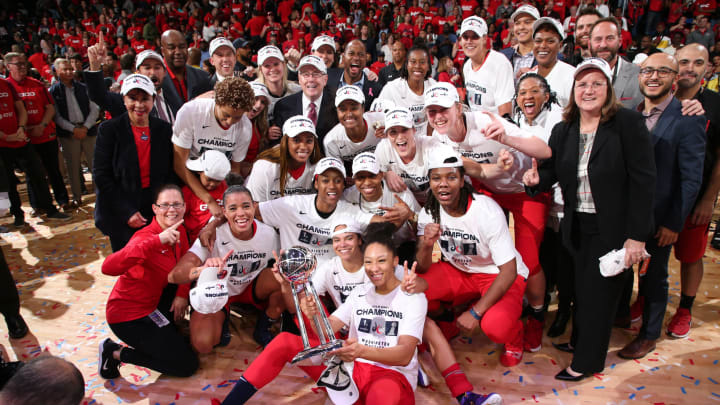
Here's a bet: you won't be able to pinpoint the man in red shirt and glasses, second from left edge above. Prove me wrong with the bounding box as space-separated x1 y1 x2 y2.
5 53 69 213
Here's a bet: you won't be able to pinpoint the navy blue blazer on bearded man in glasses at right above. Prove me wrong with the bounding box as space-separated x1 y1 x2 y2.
650 97 706 232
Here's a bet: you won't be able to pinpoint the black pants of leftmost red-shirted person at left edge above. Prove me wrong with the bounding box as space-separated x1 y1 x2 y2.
0 144 57 218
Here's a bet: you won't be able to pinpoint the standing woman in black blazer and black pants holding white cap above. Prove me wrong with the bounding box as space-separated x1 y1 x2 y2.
523 58 655 381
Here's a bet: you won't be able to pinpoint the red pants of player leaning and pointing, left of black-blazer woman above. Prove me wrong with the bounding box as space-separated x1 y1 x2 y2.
479 189 550 275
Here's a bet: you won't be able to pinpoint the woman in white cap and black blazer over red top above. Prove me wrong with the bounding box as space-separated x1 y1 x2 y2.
93 74 176 252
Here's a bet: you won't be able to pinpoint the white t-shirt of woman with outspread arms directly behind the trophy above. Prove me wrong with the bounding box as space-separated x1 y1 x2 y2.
258 194 372 264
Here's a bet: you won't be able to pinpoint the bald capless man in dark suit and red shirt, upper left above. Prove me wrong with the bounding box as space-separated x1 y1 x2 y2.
160 30 212 105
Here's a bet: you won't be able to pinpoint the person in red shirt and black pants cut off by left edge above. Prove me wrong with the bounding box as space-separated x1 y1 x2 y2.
0 73 67 226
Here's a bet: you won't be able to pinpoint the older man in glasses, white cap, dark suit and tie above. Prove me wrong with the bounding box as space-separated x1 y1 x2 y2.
272 53 338 145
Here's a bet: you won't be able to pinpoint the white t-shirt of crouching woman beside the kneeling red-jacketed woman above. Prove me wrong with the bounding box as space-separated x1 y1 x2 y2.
190 221 280 297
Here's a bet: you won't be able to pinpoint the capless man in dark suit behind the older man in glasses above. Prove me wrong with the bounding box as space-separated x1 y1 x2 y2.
328 39 382 111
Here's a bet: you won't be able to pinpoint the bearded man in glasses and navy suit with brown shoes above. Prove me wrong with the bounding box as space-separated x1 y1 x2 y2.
618 53 706 359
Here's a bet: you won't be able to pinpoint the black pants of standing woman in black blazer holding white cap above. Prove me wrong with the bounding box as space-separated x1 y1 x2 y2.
570 213 632 374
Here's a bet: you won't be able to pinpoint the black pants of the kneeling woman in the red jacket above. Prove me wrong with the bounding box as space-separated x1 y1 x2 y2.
110 316 199 377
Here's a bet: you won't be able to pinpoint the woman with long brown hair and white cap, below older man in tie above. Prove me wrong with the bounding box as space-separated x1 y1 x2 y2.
245 115 322 202
